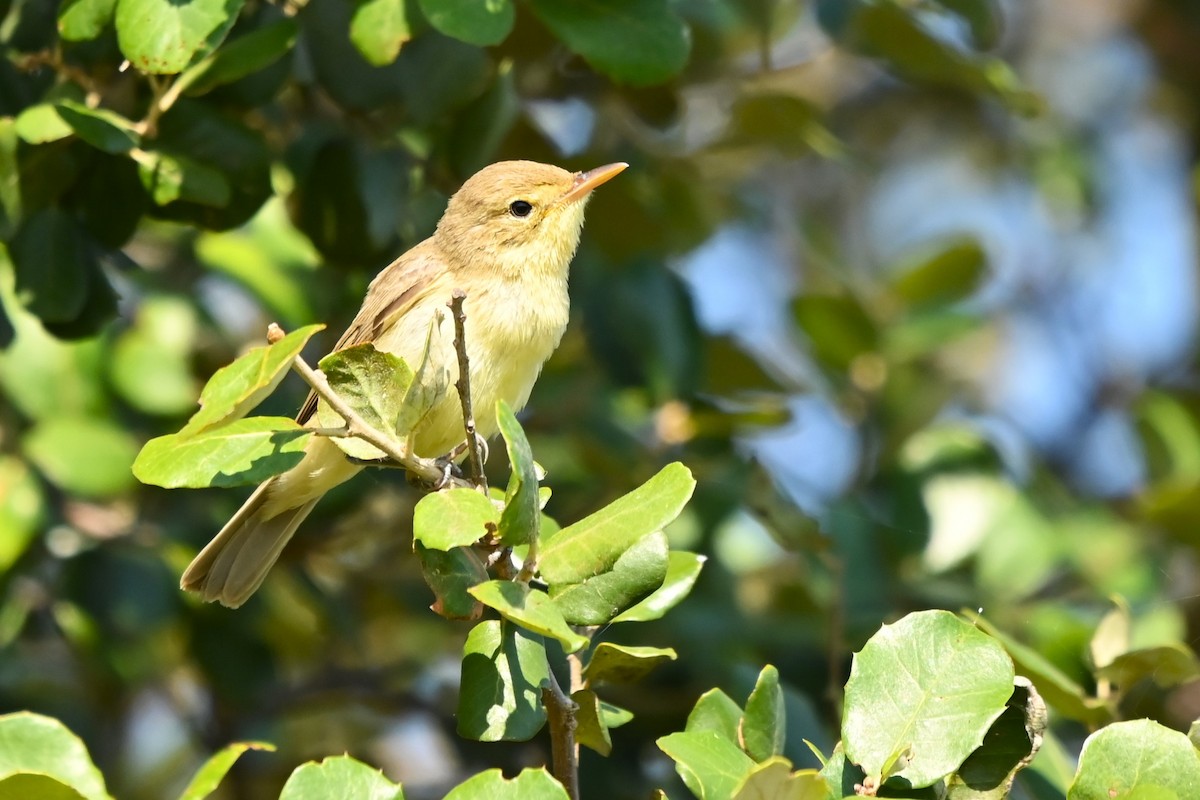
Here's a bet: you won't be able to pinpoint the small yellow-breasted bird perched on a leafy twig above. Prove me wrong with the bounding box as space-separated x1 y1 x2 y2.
180 161 628 608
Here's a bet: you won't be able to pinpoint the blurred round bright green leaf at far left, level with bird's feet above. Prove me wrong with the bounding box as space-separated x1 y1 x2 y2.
22 416 138 498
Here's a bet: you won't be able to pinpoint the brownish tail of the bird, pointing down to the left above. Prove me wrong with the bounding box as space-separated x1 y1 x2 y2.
179 479 320 608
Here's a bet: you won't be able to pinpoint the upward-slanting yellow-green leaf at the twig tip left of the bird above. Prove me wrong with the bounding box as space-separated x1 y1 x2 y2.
179 325 325 437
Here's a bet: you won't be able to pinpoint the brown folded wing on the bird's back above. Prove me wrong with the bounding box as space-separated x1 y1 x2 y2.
296 239 449 425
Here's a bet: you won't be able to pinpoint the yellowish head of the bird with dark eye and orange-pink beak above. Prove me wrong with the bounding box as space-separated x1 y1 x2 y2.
434 161 628 279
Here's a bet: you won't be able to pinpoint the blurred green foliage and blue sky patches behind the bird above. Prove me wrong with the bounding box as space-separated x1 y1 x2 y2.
0 0 1200 799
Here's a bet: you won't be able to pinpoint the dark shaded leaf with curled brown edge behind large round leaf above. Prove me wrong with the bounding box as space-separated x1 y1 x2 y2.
946 675 1046 800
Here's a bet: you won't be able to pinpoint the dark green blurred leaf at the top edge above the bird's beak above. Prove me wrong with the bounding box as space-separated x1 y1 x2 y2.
529 0 691 86
